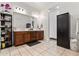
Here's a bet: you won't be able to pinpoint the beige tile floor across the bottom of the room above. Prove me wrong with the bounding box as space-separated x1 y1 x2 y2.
0 40 79 56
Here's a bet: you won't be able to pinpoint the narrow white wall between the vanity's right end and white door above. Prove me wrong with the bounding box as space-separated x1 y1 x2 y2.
39 10 49 40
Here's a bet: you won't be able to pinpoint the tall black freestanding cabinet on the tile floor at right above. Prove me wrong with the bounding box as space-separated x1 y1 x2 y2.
57 13 70 49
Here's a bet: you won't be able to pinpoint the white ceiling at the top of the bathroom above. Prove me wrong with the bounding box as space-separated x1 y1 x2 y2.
25 2 57 11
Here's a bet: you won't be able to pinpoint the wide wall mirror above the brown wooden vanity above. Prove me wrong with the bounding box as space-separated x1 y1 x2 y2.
13 13 37 29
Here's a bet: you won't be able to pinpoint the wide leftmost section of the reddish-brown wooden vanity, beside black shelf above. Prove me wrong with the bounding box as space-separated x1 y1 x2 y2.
14 32 24 46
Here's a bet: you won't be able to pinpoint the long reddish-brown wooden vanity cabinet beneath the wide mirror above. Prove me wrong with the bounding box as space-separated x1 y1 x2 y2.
14 30 44 46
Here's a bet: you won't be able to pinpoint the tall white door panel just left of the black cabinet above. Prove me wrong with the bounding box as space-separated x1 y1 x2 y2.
49 11 57 39
